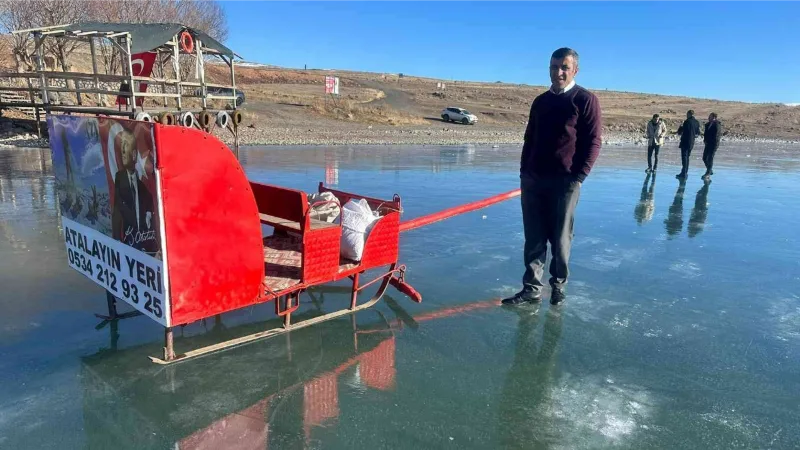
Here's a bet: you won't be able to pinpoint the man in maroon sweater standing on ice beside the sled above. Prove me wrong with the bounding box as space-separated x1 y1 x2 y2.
503 48 602 305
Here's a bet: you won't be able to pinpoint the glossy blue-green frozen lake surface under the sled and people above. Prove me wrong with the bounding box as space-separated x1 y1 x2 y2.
0 142 800 449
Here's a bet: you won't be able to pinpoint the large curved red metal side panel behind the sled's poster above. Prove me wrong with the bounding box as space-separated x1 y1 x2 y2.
155 125 264 325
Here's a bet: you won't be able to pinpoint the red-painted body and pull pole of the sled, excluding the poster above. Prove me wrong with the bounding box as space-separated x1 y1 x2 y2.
147 125 520 326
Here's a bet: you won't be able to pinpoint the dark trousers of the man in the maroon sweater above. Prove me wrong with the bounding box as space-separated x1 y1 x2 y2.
520 175 581 295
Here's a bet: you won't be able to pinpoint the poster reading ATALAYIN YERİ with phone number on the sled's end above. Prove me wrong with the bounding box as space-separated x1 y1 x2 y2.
47 115 169 326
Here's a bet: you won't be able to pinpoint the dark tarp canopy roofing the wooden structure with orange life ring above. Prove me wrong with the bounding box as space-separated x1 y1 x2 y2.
63 22 233 58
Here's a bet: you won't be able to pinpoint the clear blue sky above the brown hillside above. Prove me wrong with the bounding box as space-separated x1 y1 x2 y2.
222 0 800 103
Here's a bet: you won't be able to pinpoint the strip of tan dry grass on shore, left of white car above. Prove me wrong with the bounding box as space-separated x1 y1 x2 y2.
311 99 427 125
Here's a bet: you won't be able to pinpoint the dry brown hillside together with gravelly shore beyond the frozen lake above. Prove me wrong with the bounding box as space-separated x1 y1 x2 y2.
0 39 800 143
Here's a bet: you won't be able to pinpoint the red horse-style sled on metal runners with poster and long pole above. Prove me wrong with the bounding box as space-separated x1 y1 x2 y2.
48 116 519 364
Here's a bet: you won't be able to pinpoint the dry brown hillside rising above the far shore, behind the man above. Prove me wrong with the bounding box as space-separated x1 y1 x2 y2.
202 61 800 140
